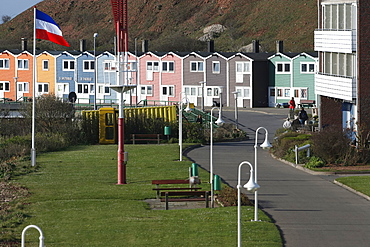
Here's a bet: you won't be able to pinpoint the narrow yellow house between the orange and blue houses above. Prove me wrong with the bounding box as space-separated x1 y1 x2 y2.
36 51 56 97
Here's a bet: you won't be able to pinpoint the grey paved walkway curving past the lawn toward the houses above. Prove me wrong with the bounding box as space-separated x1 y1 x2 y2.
187 109 370 247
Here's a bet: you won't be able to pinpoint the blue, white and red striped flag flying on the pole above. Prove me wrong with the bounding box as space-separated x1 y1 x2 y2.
35 9 69 47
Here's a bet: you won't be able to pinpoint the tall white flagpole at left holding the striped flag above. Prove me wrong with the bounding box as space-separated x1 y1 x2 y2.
31 7 36 166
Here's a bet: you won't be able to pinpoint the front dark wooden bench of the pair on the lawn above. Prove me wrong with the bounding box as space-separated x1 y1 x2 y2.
161 191 210 210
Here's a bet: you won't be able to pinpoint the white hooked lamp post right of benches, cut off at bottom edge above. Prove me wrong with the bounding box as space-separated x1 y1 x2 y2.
237 161 260 247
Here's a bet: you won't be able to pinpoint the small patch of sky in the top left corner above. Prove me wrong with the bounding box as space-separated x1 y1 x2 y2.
0 0 42 20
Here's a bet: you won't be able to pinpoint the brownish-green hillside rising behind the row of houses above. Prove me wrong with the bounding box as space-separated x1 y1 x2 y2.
0 0 317 52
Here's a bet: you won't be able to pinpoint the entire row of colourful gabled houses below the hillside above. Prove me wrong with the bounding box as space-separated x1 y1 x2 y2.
0 42 318 108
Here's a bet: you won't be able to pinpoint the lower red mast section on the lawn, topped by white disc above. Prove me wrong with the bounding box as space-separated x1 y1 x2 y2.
110 85 136 184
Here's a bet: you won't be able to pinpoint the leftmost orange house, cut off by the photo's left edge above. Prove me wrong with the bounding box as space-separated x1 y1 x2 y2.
0 51 16 101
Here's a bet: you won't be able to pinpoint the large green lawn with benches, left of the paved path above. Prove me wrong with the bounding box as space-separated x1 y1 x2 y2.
13 144 282 247
